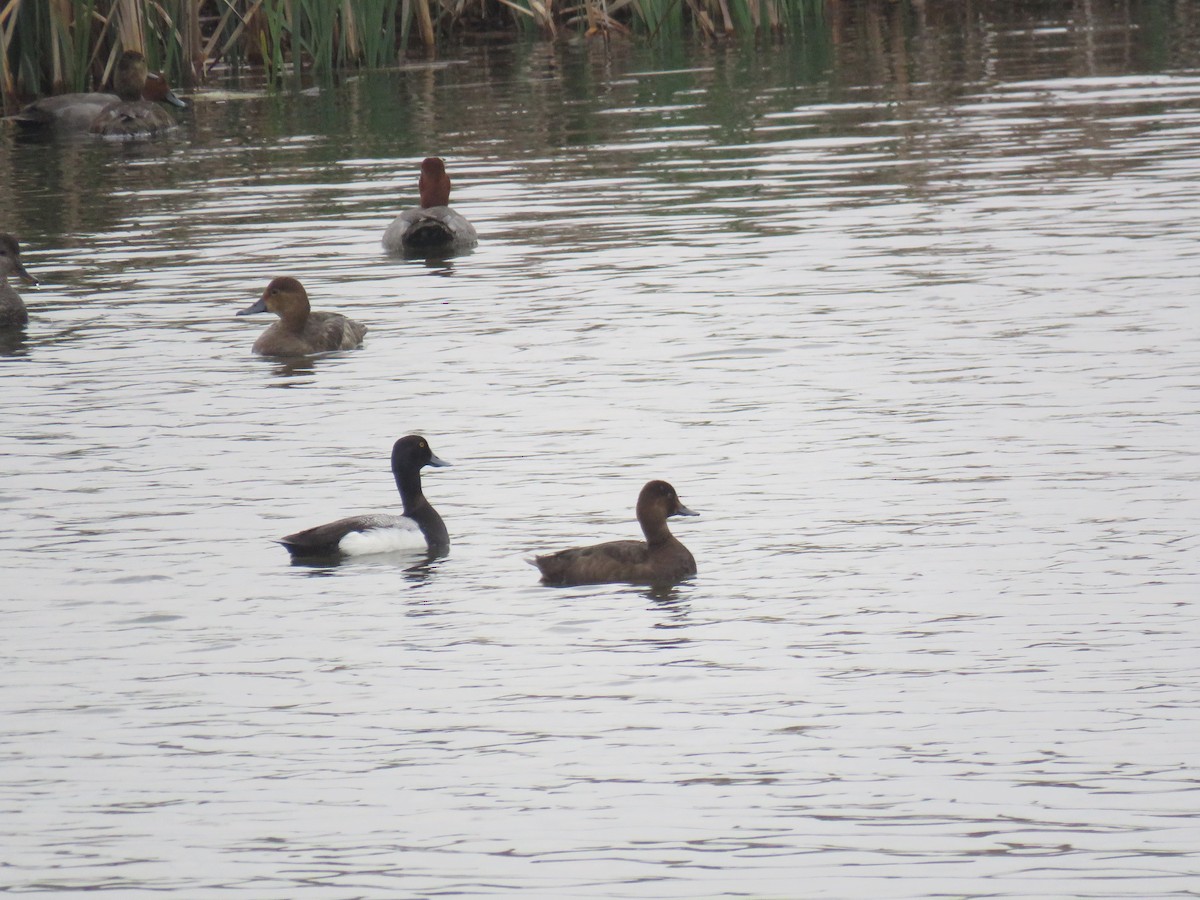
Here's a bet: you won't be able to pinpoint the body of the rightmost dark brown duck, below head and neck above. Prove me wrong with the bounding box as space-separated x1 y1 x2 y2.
534 539 696 587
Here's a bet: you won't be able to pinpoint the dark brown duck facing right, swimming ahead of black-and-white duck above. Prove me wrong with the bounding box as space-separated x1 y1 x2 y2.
530 481 700 587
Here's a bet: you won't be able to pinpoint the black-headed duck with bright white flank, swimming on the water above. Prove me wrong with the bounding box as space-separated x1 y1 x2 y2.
280 434 450 559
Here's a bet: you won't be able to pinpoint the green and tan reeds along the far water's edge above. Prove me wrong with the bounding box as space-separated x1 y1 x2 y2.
0 0 824 109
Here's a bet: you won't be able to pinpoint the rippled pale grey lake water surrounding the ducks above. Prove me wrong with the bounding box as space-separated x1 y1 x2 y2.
0 2 1200 899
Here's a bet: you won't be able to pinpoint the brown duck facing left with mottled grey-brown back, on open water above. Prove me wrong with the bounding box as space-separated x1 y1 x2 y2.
238 276 367 356
